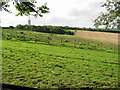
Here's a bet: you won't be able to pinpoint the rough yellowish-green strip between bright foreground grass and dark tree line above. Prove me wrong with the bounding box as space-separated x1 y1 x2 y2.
2 29 118 52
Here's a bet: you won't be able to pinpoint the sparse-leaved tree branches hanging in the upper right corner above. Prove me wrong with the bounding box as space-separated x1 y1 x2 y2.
93 0 120 29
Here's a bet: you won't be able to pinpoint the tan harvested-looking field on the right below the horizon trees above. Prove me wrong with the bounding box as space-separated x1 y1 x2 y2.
75 30 119 44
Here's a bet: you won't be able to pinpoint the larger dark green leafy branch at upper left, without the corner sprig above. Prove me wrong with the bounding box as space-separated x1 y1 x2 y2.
15 2 49 17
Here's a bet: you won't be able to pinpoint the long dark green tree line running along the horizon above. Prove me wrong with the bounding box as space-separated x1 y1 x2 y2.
2 24 120 35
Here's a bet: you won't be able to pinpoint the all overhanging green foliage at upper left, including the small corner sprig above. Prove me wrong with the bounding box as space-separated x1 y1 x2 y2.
0 0 49 17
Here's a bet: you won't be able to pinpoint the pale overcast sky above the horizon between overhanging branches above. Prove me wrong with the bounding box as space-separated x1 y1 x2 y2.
0 0 105 27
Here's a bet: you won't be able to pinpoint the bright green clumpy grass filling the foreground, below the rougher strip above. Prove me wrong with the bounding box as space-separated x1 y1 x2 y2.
2 40 118 88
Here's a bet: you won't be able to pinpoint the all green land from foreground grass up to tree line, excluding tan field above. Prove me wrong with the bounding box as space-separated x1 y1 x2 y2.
2 30 118 88
